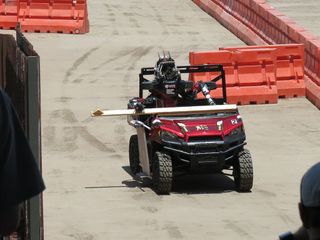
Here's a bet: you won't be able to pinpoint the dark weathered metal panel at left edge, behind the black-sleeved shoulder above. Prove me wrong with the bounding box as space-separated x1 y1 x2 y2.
0 25 44 240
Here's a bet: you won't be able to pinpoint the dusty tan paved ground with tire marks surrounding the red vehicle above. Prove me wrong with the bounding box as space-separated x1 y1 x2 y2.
13 0 320 240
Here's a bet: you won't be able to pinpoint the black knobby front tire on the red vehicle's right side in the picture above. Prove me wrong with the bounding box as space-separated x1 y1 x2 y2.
233 149 253 192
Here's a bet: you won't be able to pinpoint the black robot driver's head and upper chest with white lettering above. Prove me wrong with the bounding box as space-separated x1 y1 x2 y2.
155 53 181 98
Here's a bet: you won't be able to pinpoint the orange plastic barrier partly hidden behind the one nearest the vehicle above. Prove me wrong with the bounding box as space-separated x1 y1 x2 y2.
220 44 306 98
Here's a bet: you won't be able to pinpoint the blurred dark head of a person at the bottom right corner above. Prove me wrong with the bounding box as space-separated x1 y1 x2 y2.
299 162 320 239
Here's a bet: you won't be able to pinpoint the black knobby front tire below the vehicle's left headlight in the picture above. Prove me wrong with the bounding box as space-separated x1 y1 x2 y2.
152 152 172 194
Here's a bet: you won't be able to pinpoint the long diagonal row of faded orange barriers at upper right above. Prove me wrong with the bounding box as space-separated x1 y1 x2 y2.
193 0 320 108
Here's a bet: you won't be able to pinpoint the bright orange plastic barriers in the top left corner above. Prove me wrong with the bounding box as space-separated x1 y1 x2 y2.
0 0 89 34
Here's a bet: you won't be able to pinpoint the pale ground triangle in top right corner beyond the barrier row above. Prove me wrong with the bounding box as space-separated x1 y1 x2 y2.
268 0 320 36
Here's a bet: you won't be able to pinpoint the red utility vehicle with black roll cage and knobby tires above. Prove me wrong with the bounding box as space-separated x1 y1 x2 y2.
128 61 253 194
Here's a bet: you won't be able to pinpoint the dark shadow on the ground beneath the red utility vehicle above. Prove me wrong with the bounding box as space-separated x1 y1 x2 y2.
122 166 236 194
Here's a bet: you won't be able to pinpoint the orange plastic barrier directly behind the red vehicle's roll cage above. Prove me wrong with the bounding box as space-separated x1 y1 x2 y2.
189 49 278 105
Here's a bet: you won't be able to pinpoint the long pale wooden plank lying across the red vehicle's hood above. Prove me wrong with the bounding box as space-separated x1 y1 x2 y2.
91 104 237 117
